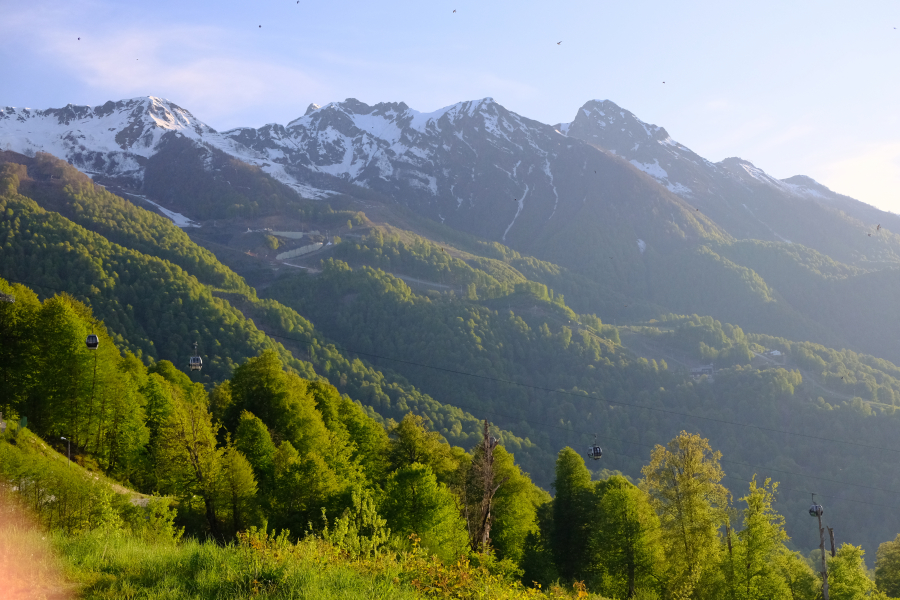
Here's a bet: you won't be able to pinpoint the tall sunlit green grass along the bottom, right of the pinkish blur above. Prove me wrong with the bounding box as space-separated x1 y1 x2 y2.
54 530 599 600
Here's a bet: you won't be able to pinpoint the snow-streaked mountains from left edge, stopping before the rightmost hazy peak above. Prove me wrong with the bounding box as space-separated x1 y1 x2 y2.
0 97 723 266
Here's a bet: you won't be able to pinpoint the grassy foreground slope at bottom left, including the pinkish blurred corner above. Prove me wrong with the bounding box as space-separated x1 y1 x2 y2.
0 426 599 600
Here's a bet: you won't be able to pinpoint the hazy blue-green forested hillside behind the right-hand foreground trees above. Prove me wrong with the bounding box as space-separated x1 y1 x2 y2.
265 232 900 548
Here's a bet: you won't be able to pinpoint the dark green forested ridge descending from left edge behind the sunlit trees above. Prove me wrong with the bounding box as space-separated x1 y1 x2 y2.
0 157 548 469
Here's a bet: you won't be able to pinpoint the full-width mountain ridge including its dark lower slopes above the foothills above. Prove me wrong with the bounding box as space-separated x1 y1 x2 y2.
7 97 900 368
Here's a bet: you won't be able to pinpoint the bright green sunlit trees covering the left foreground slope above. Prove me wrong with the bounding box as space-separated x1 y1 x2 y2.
0 280 549 596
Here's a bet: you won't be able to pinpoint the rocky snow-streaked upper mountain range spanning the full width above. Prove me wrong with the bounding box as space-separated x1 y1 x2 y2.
0 97 900 303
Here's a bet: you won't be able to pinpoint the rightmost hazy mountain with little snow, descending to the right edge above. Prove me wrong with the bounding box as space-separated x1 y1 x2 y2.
556 100 900 265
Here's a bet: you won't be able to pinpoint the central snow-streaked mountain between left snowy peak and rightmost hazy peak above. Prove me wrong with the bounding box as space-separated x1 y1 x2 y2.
224 98 715 260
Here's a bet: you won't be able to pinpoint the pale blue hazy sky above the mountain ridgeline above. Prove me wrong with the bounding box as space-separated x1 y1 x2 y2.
0 0 900 213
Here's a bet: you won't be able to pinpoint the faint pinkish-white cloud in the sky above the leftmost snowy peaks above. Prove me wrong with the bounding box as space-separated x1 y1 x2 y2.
0 7 328 129
